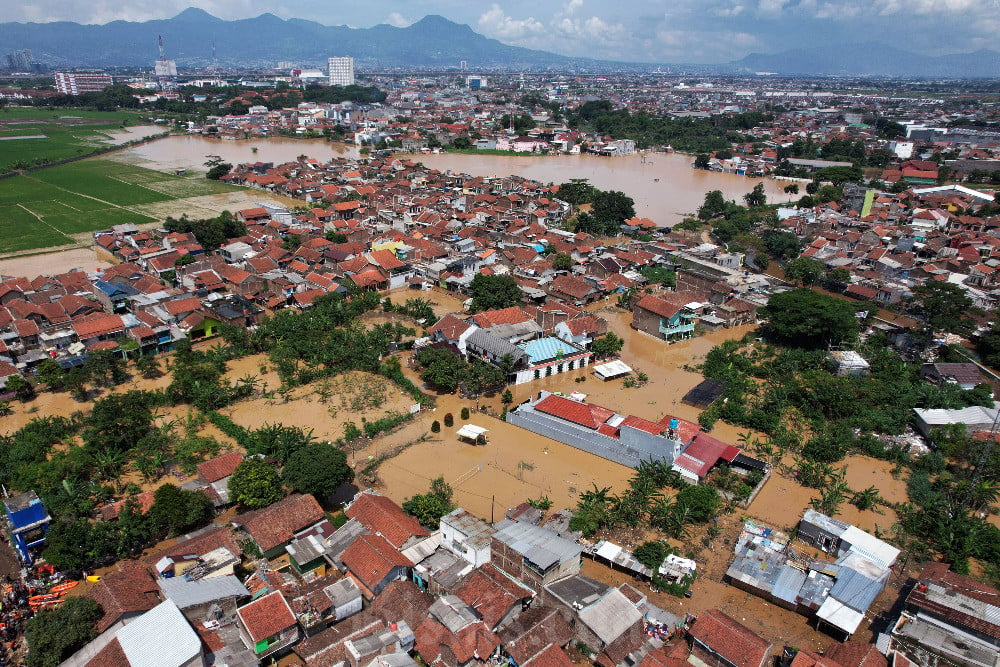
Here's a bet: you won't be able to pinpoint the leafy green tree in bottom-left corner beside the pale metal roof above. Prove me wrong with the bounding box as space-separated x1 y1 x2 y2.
24 595 104 667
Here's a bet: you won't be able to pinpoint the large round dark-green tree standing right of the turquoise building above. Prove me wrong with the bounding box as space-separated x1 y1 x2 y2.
760 288 860 348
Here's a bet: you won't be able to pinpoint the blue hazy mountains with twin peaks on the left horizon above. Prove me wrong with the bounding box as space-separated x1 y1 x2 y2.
0 8 586 67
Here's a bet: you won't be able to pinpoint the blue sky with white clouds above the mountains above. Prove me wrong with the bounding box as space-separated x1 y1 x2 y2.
7 0 1000 63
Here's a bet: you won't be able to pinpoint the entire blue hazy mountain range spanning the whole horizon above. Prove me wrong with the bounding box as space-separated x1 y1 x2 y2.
0 8 1000 78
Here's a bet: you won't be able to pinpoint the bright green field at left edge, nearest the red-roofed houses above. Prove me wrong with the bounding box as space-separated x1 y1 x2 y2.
0 159 241 253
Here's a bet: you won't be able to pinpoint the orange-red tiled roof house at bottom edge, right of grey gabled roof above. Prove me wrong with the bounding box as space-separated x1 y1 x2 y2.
688 609 774 667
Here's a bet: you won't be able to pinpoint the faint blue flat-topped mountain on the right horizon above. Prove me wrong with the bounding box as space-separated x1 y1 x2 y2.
733 42 1000 78
